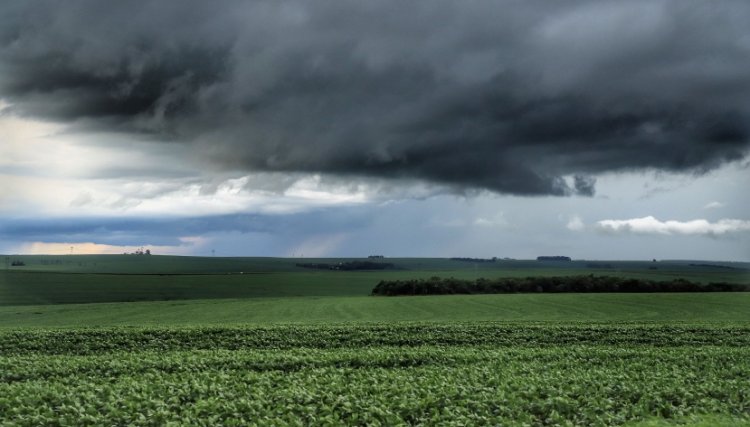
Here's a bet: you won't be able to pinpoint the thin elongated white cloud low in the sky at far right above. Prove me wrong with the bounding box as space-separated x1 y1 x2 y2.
594 216 750 236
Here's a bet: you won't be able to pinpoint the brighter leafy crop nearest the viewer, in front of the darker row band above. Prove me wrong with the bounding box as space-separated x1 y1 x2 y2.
0 345 750 425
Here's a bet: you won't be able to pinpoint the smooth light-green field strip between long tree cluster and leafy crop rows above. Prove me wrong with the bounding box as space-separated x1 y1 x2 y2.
0 293 750 328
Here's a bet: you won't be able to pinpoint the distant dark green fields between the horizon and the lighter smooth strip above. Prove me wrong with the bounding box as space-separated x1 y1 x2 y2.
0 255 750 305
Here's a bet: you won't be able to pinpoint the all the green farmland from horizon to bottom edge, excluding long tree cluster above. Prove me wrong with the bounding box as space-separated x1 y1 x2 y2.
0 256 750 426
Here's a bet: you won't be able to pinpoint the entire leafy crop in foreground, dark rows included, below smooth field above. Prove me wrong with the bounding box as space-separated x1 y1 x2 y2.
0 323 750 426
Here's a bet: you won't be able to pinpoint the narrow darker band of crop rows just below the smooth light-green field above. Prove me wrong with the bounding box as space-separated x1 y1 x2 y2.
0 322 750 355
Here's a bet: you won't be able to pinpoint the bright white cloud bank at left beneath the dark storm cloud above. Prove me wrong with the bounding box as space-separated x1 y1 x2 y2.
0 108 464 217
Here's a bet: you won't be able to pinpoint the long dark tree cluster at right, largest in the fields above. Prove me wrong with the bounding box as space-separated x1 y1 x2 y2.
372 275 750 296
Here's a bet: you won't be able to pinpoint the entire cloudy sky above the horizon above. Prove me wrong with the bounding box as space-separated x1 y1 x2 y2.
0 0 750 261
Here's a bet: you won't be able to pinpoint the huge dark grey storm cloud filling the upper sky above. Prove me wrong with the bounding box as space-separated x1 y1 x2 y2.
0 0 750 195
